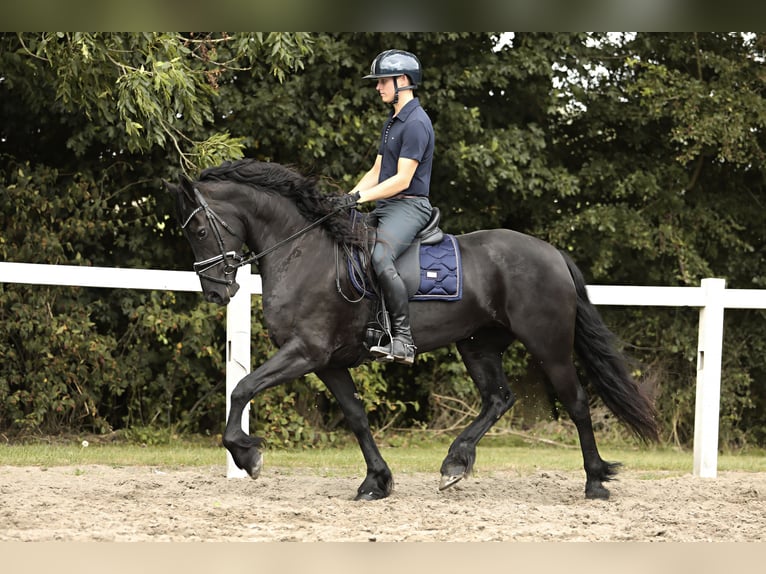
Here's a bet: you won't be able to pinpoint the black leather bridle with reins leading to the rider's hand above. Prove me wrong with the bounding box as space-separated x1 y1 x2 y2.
181 187 350 286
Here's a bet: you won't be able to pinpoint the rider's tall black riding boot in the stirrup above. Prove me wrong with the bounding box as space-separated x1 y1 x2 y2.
370 269 416 365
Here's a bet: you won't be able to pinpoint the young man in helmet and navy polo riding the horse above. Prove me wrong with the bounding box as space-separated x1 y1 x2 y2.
350 50 434 365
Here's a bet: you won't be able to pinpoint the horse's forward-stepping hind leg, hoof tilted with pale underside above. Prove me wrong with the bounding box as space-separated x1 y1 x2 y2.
439 328 516 490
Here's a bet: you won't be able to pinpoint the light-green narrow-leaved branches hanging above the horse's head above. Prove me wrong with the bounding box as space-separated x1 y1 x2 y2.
2 32 310 174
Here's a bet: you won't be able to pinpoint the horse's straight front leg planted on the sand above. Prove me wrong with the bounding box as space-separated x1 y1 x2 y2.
316 369 394 500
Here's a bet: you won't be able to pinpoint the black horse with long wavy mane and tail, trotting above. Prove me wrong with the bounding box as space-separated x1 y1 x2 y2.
166 159 658 500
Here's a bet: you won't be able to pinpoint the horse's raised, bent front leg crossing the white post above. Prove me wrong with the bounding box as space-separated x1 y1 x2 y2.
223 342 315 478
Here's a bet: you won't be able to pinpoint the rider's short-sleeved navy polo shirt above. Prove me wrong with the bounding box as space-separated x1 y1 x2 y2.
378 98 434 197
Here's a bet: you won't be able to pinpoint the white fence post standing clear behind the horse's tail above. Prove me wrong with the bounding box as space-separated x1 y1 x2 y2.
694 279 726 478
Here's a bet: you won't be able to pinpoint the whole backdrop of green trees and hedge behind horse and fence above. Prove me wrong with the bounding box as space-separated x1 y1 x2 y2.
0 32 766 446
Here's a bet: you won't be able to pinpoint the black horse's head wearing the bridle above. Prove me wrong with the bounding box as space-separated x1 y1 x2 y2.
165 176 245 305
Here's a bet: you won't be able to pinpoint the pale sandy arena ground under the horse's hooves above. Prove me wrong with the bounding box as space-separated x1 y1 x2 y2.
0 466 766 542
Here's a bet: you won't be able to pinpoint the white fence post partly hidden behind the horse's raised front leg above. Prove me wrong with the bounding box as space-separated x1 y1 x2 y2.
226 265 254 478
